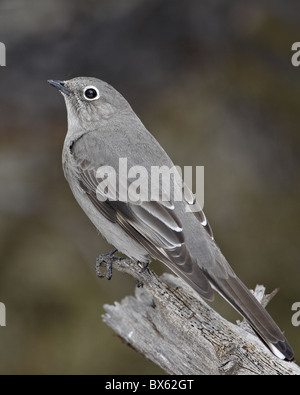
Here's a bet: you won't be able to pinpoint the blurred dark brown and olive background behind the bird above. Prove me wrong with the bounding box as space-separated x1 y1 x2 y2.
0 0 300 374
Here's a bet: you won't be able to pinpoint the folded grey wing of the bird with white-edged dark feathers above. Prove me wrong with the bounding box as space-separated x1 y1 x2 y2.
72 137 213 300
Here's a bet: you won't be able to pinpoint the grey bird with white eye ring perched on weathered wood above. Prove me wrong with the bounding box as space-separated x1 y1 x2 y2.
48 77 294 361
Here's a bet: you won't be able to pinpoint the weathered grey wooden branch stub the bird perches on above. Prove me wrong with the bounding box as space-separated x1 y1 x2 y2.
101 257 300 375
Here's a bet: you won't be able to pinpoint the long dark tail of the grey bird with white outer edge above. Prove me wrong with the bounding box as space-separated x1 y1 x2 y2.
210 276 294 361
